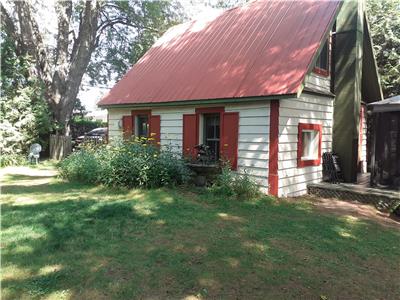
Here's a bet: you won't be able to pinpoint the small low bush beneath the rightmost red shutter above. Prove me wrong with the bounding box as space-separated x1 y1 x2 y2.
210 166 260 199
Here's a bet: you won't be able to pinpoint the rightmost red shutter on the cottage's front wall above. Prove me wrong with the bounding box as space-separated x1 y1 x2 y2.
220 112 239 170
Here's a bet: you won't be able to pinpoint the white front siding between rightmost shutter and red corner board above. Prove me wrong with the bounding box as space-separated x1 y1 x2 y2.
225 102 270 191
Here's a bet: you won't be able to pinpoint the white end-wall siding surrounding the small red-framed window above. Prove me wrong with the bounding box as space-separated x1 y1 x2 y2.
278 93 333 197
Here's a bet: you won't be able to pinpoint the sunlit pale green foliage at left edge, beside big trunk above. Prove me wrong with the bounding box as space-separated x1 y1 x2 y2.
0 35 51 164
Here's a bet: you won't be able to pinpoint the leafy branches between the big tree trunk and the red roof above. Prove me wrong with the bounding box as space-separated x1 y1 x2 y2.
87 1 184 84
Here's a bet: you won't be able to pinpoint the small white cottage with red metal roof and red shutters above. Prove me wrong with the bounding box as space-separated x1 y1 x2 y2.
98 0 382 196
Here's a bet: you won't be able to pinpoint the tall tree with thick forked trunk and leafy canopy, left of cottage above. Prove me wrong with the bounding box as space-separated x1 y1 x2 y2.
0 0 181 134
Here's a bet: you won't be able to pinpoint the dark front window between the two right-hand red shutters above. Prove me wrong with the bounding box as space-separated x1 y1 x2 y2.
203 113 220 160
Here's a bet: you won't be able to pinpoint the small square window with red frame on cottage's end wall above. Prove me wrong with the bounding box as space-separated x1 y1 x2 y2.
297 123 322 168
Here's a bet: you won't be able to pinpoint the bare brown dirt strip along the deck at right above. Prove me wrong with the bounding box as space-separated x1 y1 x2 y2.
302 196 400 230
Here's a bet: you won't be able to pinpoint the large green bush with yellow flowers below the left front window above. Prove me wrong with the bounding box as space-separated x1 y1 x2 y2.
60 139 190 188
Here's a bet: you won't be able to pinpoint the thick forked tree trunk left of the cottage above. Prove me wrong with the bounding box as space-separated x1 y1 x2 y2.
7 0 102 135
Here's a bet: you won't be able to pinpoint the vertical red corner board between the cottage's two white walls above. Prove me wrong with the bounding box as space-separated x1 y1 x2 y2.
268 100 279 196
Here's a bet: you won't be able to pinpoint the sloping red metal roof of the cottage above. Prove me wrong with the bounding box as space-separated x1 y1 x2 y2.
99 0 340 105
